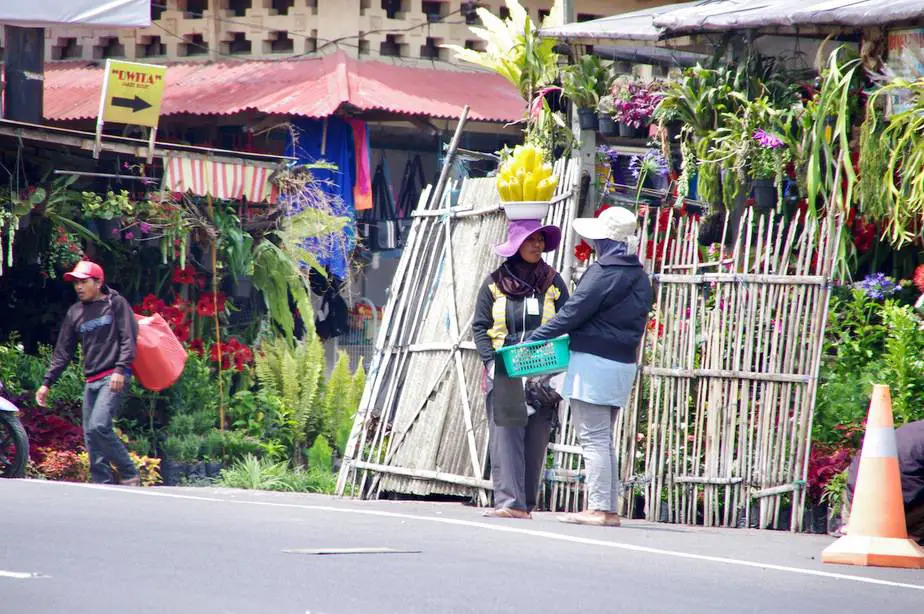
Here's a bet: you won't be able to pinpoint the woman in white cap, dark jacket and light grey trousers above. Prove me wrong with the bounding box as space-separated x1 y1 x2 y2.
530 207 652 526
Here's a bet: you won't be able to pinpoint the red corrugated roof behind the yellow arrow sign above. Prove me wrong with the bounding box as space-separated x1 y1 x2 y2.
45 52 525 122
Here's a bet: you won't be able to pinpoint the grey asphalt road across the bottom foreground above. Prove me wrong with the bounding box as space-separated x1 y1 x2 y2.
0 480 924 614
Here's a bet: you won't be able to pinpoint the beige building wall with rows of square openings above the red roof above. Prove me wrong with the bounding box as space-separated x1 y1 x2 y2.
0 0 669 63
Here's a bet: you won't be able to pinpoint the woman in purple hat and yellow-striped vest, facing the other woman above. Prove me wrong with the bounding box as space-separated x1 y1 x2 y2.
472 220 568 519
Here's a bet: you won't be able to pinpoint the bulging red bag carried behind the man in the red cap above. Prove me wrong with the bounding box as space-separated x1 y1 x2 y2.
132 313 186 392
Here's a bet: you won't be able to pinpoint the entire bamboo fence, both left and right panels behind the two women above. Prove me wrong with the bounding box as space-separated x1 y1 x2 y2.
338 161 840 530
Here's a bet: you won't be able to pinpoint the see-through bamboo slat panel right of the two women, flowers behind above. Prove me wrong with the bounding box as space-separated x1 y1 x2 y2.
549 209 840 530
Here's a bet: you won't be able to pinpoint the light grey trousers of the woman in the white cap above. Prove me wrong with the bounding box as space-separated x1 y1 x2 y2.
571 399 619 512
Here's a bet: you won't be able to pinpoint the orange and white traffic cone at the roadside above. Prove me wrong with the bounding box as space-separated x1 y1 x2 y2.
821 384 924 569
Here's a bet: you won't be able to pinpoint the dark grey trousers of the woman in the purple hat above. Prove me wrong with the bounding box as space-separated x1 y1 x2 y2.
485 392 555 512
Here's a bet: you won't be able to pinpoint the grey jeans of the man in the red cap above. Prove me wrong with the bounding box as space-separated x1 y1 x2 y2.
83 377 138 484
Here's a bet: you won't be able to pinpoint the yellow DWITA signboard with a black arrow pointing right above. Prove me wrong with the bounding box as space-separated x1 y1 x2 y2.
100 60 167 128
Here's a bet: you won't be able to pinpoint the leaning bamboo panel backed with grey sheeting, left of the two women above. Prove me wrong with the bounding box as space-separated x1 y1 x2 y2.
338 160 578 505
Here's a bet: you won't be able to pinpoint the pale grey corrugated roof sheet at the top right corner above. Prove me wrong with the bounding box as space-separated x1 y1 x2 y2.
654 0 924 34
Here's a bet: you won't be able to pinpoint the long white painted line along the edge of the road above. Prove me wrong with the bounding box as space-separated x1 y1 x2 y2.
14 480 924 591
